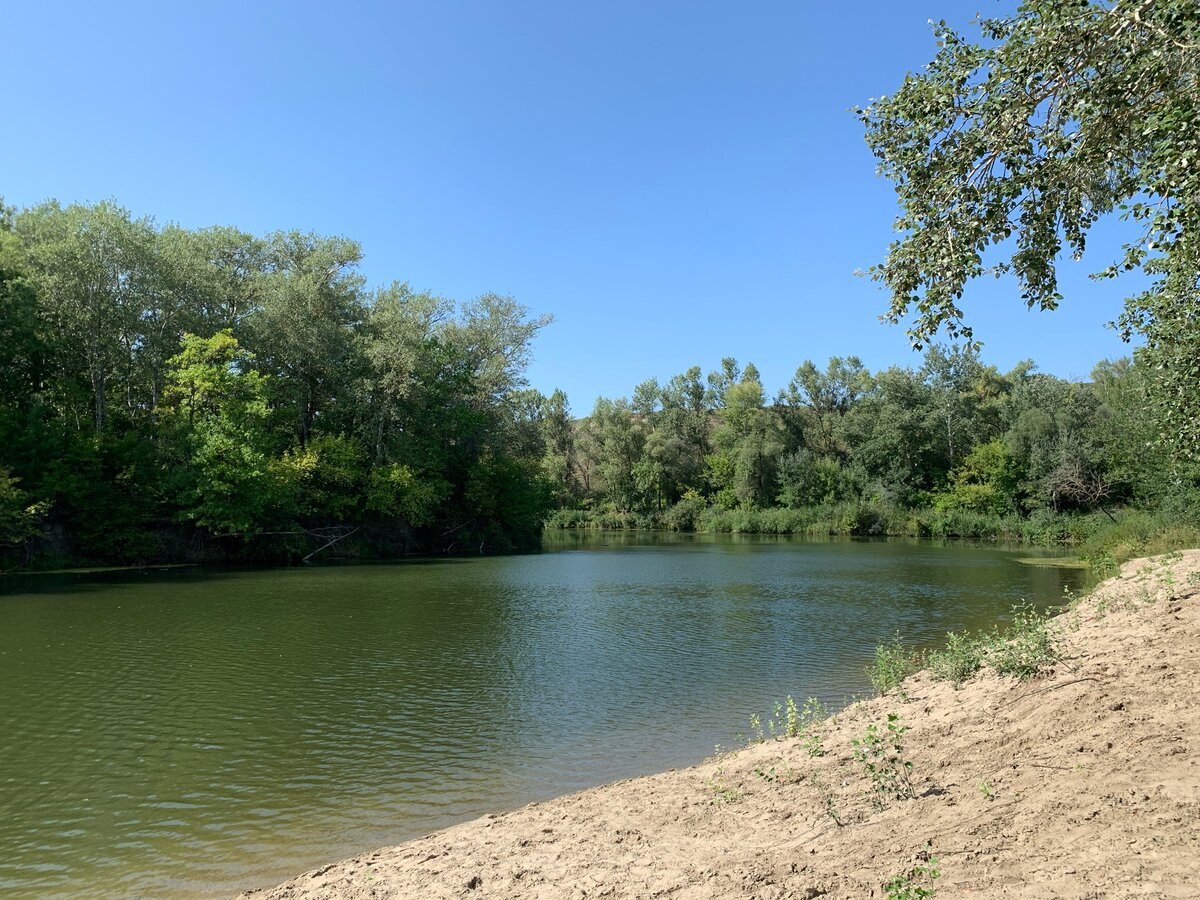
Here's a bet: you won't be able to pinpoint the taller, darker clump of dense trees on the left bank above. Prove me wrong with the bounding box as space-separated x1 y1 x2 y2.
0 202 550 565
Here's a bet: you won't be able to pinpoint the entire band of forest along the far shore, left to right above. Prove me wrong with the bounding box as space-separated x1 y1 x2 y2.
0 196 1200 568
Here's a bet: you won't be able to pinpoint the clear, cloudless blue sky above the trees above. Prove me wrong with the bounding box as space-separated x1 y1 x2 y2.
0 0 1135 414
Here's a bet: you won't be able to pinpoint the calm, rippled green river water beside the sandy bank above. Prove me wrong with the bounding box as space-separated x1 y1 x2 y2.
0 534 1081 898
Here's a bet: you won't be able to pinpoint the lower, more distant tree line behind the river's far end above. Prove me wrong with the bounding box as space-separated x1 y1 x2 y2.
546 344 1200 539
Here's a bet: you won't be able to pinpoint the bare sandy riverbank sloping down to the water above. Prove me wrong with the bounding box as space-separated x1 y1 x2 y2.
236 551 1200 900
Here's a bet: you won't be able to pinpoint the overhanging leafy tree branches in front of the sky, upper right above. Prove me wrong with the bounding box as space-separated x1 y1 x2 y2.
857 0 1200 456
